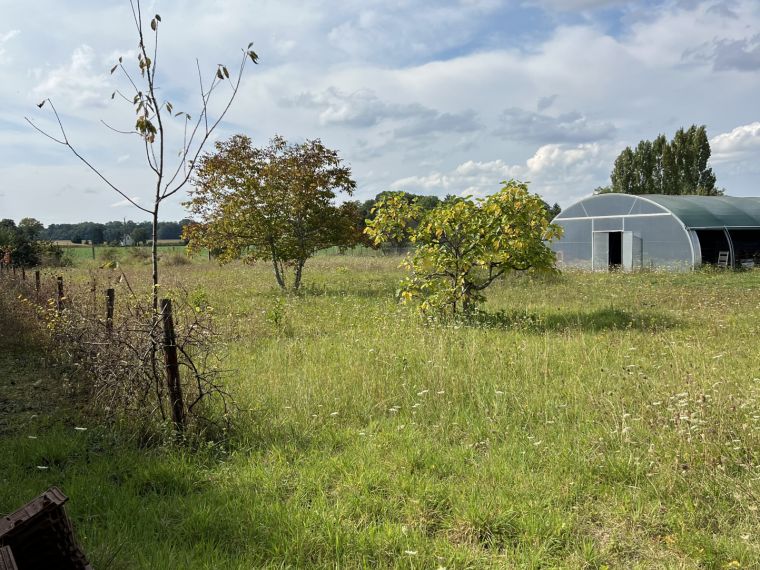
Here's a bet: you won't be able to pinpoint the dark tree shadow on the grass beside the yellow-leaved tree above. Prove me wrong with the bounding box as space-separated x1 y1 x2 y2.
468 308 679 333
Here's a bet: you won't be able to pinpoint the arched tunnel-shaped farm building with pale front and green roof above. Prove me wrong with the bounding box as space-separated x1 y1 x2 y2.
552 194 760 271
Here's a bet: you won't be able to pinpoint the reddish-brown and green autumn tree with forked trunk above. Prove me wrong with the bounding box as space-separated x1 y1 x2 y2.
183 135 362 289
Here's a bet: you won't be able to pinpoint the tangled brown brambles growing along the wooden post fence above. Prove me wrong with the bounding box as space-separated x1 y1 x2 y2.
4 272 232 430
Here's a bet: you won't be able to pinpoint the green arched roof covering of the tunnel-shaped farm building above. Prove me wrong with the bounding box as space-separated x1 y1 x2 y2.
639 194 760 228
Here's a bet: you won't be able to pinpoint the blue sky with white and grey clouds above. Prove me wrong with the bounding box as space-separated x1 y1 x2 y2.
0 0 760 225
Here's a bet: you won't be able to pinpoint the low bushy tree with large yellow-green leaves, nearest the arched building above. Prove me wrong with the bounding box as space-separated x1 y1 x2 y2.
365 180 560 315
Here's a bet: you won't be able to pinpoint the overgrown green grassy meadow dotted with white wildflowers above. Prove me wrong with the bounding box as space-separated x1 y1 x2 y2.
0 256 760 569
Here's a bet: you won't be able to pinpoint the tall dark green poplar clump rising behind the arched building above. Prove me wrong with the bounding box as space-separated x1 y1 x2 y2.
608 125 723 196
